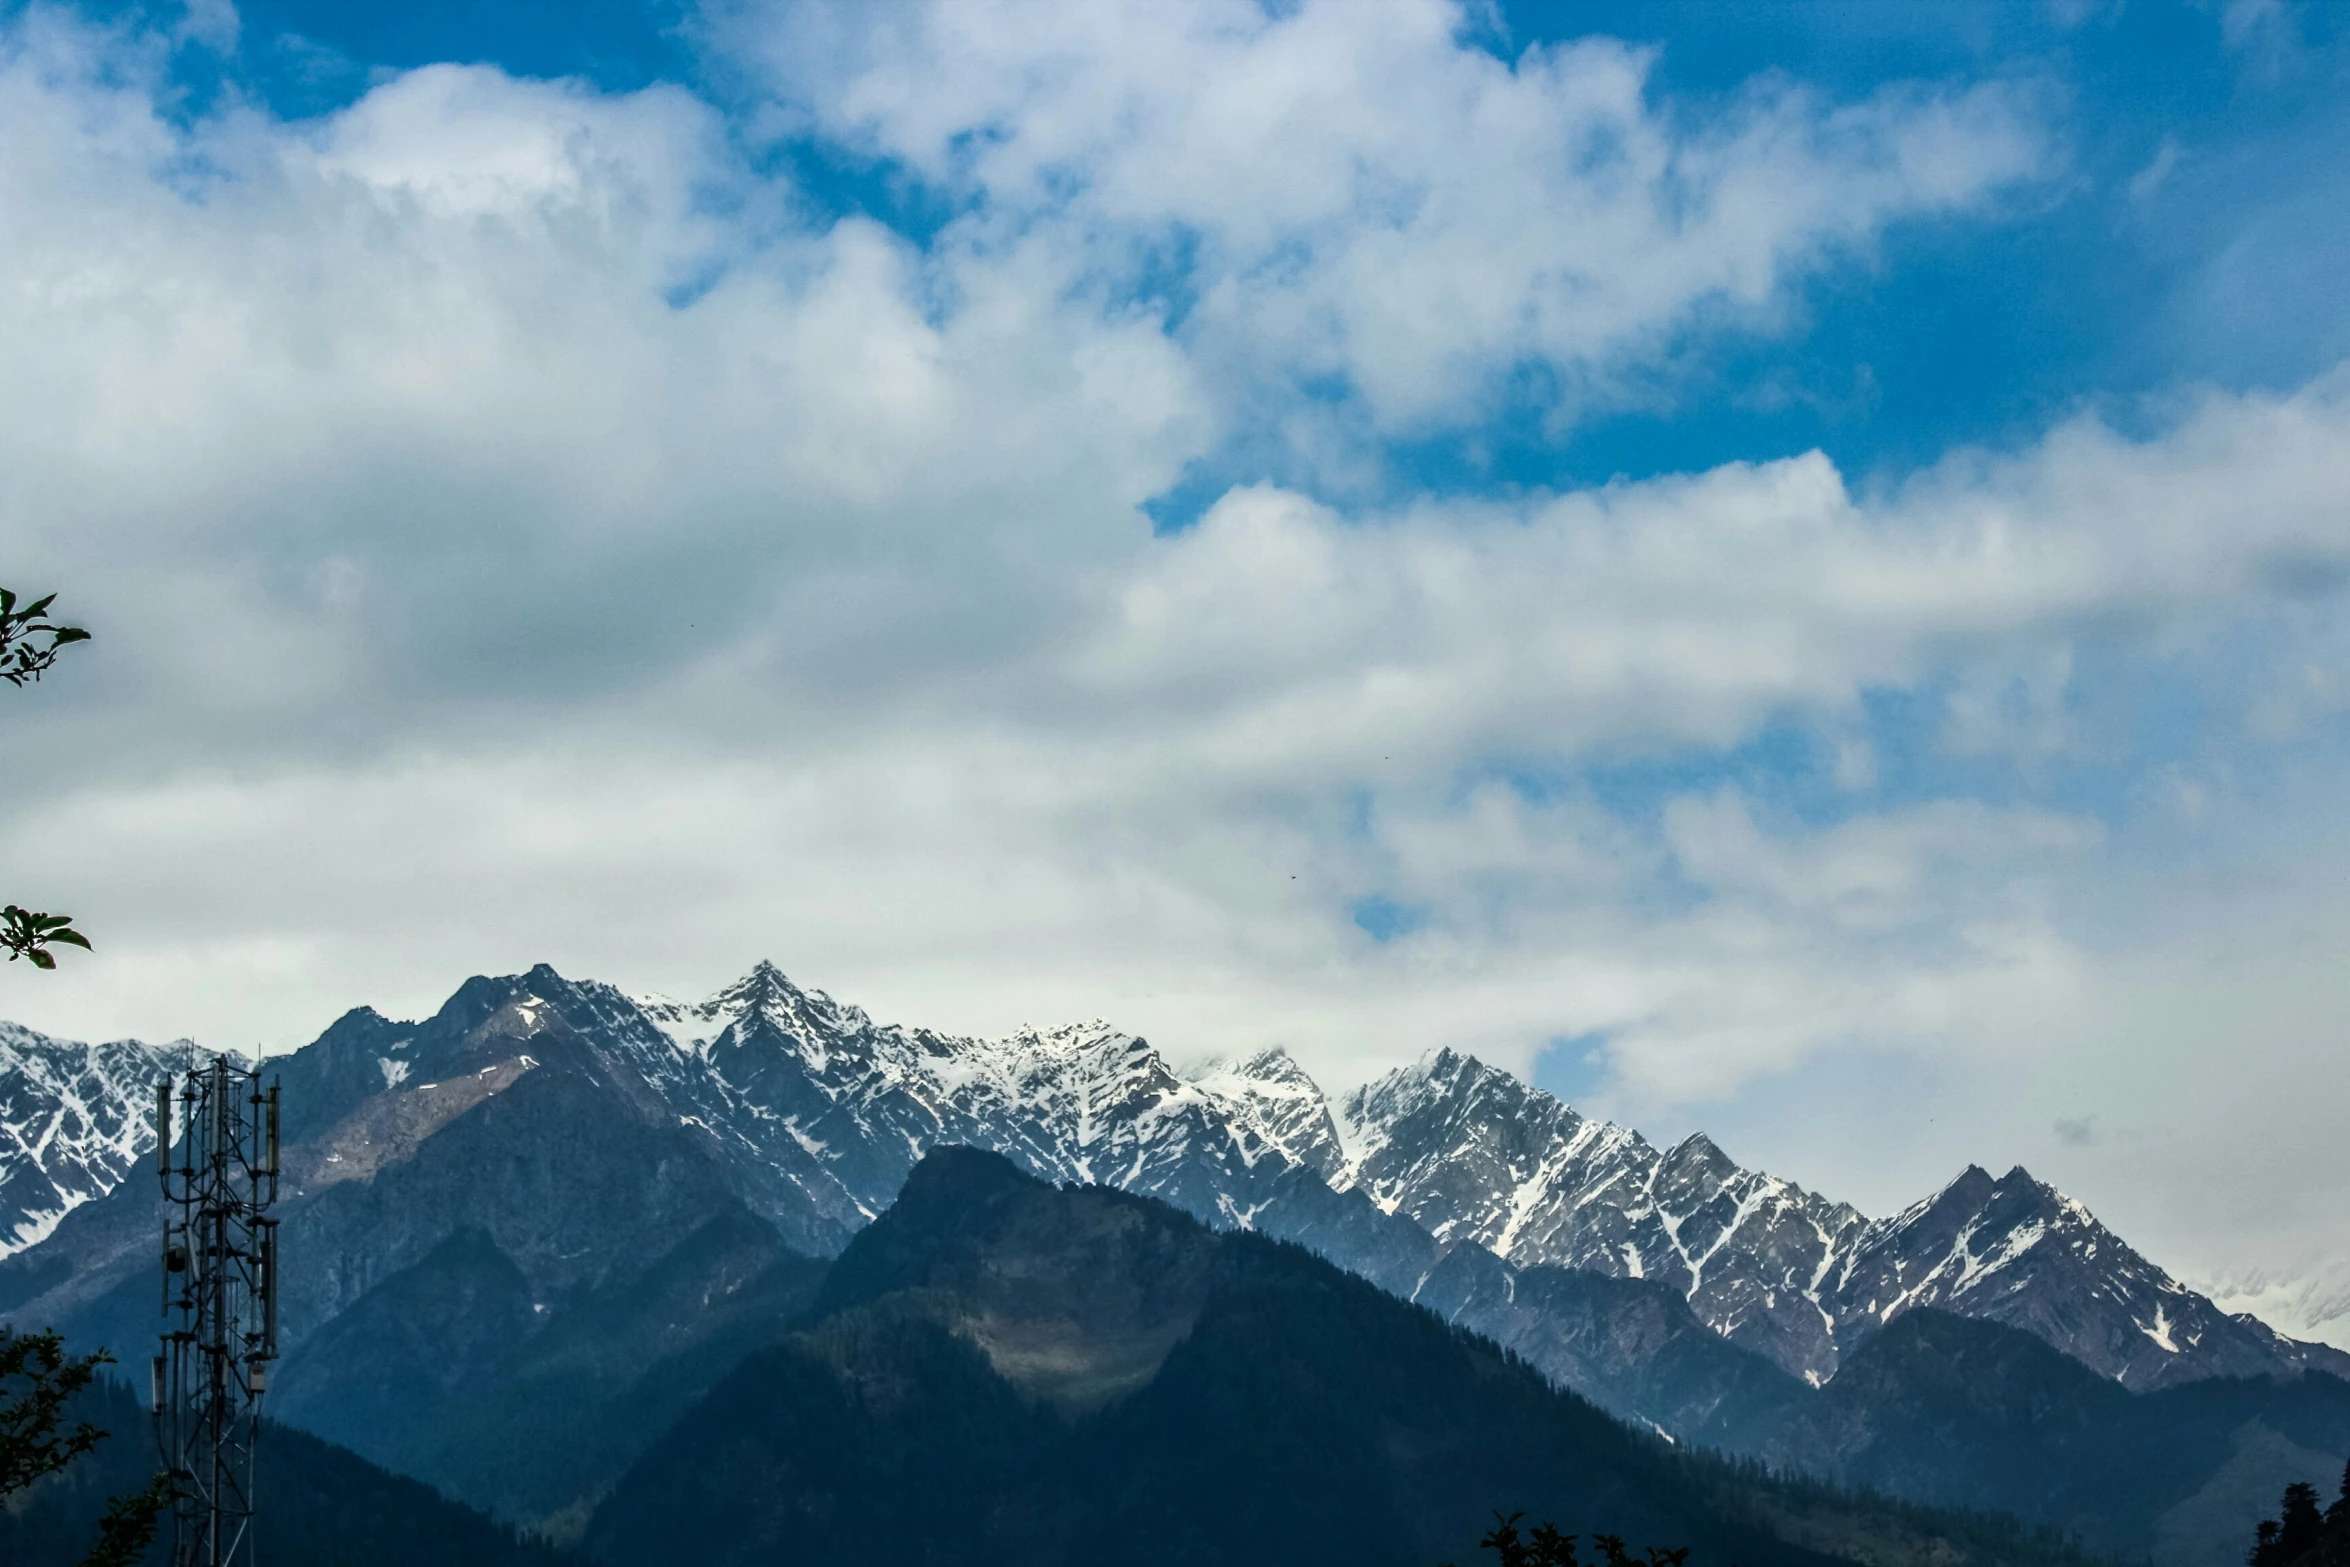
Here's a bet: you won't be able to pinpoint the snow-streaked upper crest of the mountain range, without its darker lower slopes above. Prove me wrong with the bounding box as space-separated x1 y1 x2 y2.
0 963 2350 1388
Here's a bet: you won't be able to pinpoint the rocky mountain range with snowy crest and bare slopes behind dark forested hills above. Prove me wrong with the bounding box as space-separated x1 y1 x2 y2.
0 963 2350 1440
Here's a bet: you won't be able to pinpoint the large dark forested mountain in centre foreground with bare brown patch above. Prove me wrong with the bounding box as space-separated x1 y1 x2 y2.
583 1149 2105 1567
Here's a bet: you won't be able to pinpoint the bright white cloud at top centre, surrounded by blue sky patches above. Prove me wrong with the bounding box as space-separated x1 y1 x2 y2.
719 0 2052 441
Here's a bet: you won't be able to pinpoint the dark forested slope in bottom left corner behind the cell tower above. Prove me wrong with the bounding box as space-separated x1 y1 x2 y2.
0 1384 573 1567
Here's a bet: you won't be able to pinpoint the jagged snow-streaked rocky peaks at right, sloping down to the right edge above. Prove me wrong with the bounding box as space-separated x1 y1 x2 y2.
1337 1050 2350 1391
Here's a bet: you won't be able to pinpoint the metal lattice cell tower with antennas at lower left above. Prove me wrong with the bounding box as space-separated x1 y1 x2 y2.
153 1055 277 1567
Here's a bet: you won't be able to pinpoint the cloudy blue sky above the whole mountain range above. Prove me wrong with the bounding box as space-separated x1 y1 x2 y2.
0 0 2350 1344
